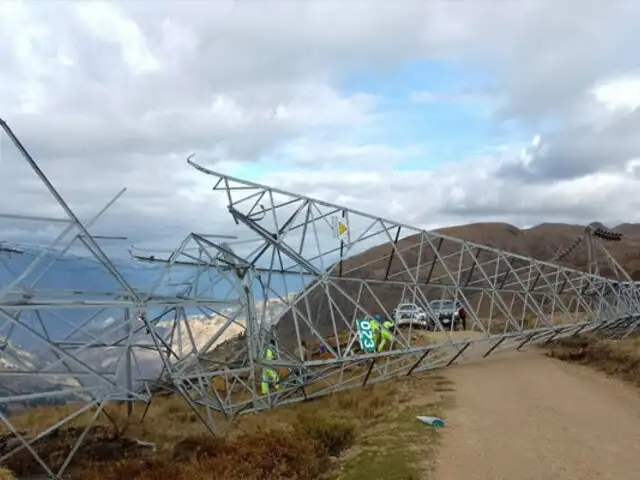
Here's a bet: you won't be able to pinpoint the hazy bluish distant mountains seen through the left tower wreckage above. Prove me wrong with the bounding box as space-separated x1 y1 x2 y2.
0 244 296 407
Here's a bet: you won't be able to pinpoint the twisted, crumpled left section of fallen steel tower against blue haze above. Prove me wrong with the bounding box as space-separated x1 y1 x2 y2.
0 120 244 478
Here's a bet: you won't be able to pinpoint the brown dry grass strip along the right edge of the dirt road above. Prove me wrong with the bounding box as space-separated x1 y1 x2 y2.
547 335 640 387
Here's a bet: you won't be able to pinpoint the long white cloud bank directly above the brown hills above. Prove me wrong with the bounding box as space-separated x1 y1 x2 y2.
258 158 640 228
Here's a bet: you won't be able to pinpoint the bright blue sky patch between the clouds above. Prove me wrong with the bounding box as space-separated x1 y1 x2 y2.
222 61 537 181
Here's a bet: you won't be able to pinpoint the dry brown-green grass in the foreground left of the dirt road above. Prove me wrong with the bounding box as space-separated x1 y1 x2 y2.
0 366 450 480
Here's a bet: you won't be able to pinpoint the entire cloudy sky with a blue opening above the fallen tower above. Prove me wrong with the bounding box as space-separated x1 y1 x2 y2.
0 0 640 258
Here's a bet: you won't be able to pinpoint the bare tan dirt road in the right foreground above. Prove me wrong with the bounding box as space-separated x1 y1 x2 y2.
434 351 640 480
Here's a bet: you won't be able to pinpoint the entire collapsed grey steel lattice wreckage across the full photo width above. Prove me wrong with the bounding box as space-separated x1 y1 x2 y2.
0 122 640 478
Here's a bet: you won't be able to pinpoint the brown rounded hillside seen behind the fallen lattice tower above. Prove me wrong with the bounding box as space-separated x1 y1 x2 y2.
278 223 640 341
